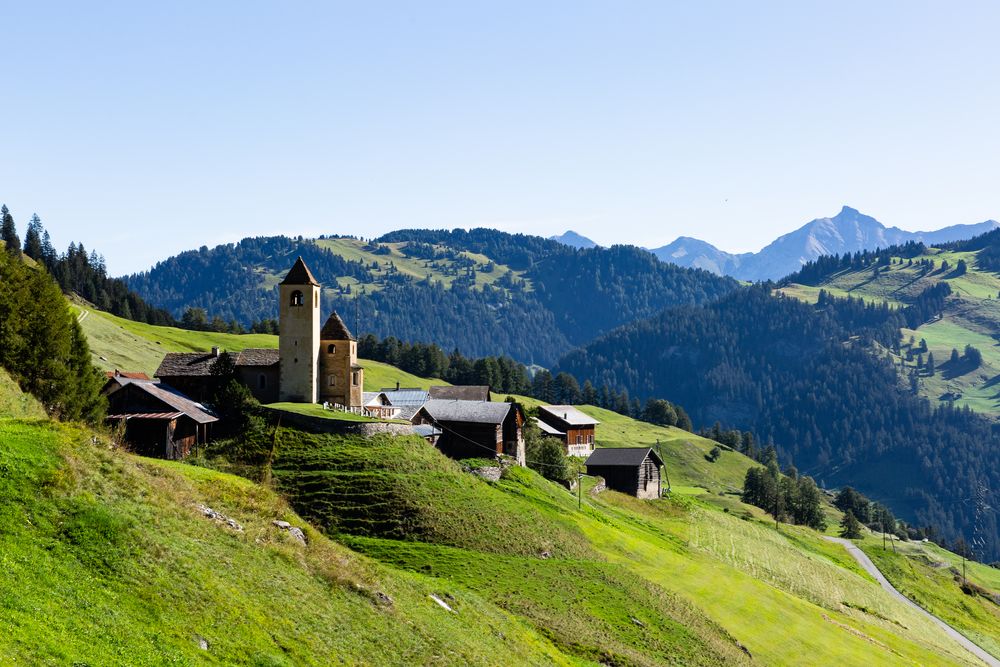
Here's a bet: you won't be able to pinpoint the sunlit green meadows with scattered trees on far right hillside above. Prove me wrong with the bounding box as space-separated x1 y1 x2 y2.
779 248 1000 416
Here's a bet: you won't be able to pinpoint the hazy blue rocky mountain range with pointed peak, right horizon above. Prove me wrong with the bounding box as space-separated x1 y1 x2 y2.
650 206 1000 281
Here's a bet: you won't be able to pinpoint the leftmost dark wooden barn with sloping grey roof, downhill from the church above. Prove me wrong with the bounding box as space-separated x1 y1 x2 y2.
104 377 219 459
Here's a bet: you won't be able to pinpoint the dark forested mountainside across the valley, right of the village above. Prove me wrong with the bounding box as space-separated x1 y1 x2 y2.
554 286 1000 560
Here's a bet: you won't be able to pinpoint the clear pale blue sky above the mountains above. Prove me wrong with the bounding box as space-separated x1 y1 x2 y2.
0 0 1000 274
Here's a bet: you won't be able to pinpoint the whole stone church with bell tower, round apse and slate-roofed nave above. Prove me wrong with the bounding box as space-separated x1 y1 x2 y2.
156 257 364 408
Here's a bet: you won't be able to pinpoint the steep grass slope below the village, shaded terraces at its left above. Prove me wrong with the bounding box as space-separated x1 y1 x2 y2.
266 430 992 665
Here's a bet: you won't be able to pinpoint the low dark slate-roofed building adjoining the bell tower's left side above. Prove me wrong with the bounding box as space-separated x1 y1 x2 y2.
155 347 280 403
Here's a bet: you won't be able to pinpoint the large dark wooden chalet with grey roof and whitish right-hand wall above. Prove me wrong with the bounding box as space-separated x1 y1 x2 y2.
411 400 524 465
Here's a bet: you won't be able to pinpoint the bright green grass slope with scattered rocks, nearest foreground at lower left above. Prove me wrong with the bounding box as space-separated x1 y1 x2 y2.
0 420 568 665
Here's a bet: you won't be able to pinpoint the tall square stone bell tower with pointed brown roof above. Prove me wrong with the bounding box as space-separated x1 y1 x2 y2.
278 257 320 403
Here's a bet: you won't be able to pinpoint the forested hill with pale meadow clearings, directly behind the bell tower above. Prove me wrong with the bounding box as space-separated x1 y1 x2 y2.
127 229 736 364
